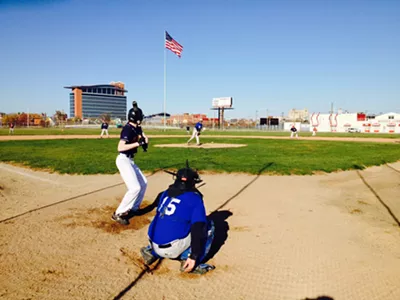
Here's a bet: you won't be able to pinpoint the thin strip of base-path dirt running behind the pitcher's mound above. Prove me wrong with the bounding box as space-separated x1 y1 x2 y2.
0 134 400 143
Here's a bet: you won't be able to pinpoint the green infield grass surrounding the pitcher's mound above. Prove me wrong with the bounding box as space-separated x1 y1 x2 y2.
0 138 400 174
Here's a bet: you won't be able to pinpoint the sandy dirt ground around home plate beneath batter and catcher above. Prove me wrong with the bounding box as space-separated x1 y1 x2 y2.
0 162 400 300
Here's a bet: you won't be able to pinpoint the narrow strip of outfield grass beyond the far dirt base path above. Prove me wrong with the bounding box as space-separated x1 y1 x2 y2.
0 128 400 139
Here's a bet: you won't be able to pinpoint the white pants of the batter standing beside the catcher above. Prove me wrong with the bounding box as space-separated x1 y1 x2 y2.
115 154 147 215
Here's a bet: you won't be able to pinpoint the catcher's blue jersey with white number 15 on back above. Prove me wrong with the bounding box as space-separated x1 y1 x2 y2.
148 191 207 245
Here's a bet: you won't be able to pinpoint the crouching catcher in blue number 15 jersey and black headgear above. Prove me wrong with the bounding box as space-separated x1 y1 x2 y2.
140 166 215 274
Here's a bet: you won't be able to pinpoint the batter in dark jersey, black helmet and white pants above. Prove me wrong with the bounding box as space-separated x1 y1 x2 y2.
112 110 147 225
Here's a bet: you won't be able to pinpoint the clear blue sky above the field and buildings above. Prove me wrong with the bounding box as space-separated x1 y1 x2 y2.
0 0 400 118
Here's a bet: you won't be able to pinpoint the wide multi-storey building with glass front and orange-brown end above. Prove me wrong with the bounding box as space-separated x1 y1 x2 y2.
65 82 128 120
